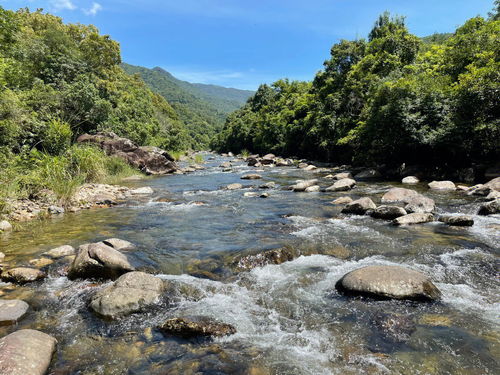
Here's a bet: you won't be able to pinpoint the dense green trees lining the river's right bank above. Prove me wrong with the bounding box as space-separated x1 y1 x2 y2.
212 5 500 165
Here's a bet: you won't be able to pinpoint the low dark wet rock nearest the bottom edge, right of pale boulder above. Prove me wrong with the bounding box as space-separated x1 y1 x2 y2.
160 318 236 338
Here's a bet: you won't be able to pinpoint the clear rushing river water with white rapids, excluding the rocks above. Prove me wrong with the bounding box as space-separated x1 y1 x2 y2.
0 156 500 375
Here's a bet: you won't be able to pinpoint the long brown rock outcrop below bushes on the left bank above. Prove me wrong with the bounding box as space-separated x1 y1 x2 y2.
77 132 178 174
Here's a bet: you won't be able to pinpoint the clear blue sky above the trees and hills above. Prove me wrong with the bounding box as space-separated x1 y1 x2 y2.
0 0 493 89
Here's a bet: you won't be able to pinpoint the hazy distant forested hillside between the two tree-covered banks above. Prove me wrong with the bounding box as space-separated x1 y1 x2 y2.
122 64 254 147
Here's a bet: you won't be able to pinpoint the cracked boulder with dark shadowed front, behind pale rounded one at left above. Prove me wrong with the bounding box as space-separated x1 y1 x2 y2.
68 243 134 280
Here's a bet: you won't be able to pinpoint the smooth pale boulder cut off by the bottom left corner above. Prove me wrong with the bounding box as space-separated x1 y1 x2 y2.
0 329 57 375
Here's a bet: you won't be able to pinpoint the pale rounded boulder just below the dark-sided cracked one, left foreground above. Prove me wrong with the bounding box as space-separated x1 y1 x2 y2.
90 272 165 318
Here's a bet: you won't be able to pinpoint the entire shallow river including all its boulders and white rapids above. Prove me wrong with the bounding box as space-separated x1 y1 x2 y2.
0 154 500 375
